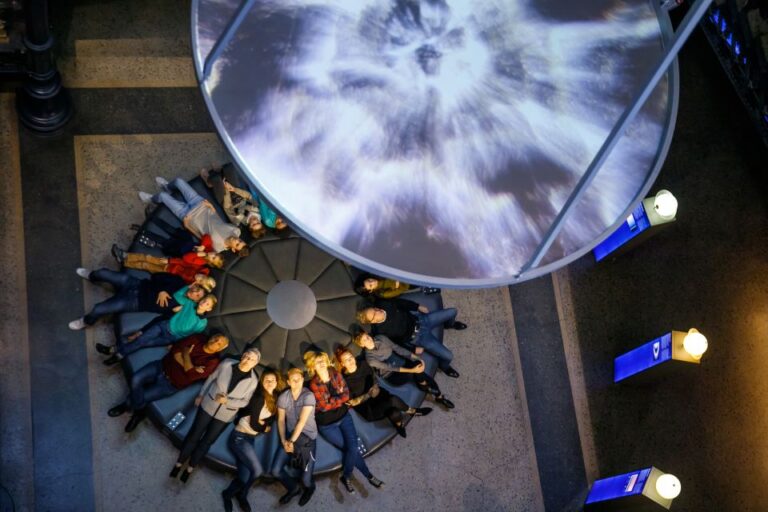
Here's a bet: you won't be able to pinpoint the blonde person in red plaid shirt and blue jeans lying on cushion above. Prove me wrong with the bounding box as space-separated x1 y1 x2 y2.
304 351 383 494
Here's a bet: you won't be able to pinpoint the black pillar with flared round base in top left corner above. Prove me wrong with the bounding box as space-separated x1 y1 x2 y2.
16 0 72 133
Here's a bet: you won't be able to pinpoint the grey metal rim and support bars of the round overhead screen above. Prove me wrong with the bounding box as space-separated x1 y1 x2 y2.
191 0 712 288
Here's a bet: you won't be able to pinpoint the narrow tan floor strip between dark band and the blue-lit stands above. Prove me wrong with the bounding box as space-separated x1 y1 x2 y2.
552 268 599 484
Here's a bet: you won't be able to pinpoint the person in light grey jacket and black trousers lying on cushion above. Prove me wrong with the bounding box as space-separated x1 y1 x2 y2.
169 348 261 483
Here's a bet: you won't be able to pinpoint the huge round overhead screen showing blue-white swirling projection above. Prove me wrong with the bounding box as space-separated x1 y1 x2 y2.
192 0 677 287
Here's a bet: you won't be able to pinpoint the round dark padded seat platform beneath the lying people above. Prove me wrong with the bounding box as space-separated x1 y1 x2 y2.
115 179 442 474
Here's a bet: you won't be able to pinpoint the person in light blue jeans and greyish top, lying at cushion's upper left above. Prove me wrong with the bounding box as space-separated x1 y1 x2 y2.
139 176 248 257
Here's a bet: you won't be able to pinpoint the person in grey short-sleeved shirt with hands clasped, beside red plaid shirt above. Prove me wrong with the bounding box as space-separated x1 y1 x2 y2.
272 368 317 507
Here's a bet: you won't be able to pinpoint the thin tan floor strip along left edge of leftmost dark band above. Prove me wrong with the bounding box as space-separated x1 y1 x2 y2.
0 93 35 510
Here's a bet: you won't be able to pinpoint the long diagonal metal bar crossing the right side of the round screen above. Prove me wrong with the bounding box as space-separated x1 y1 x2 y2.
517 0 712 278
